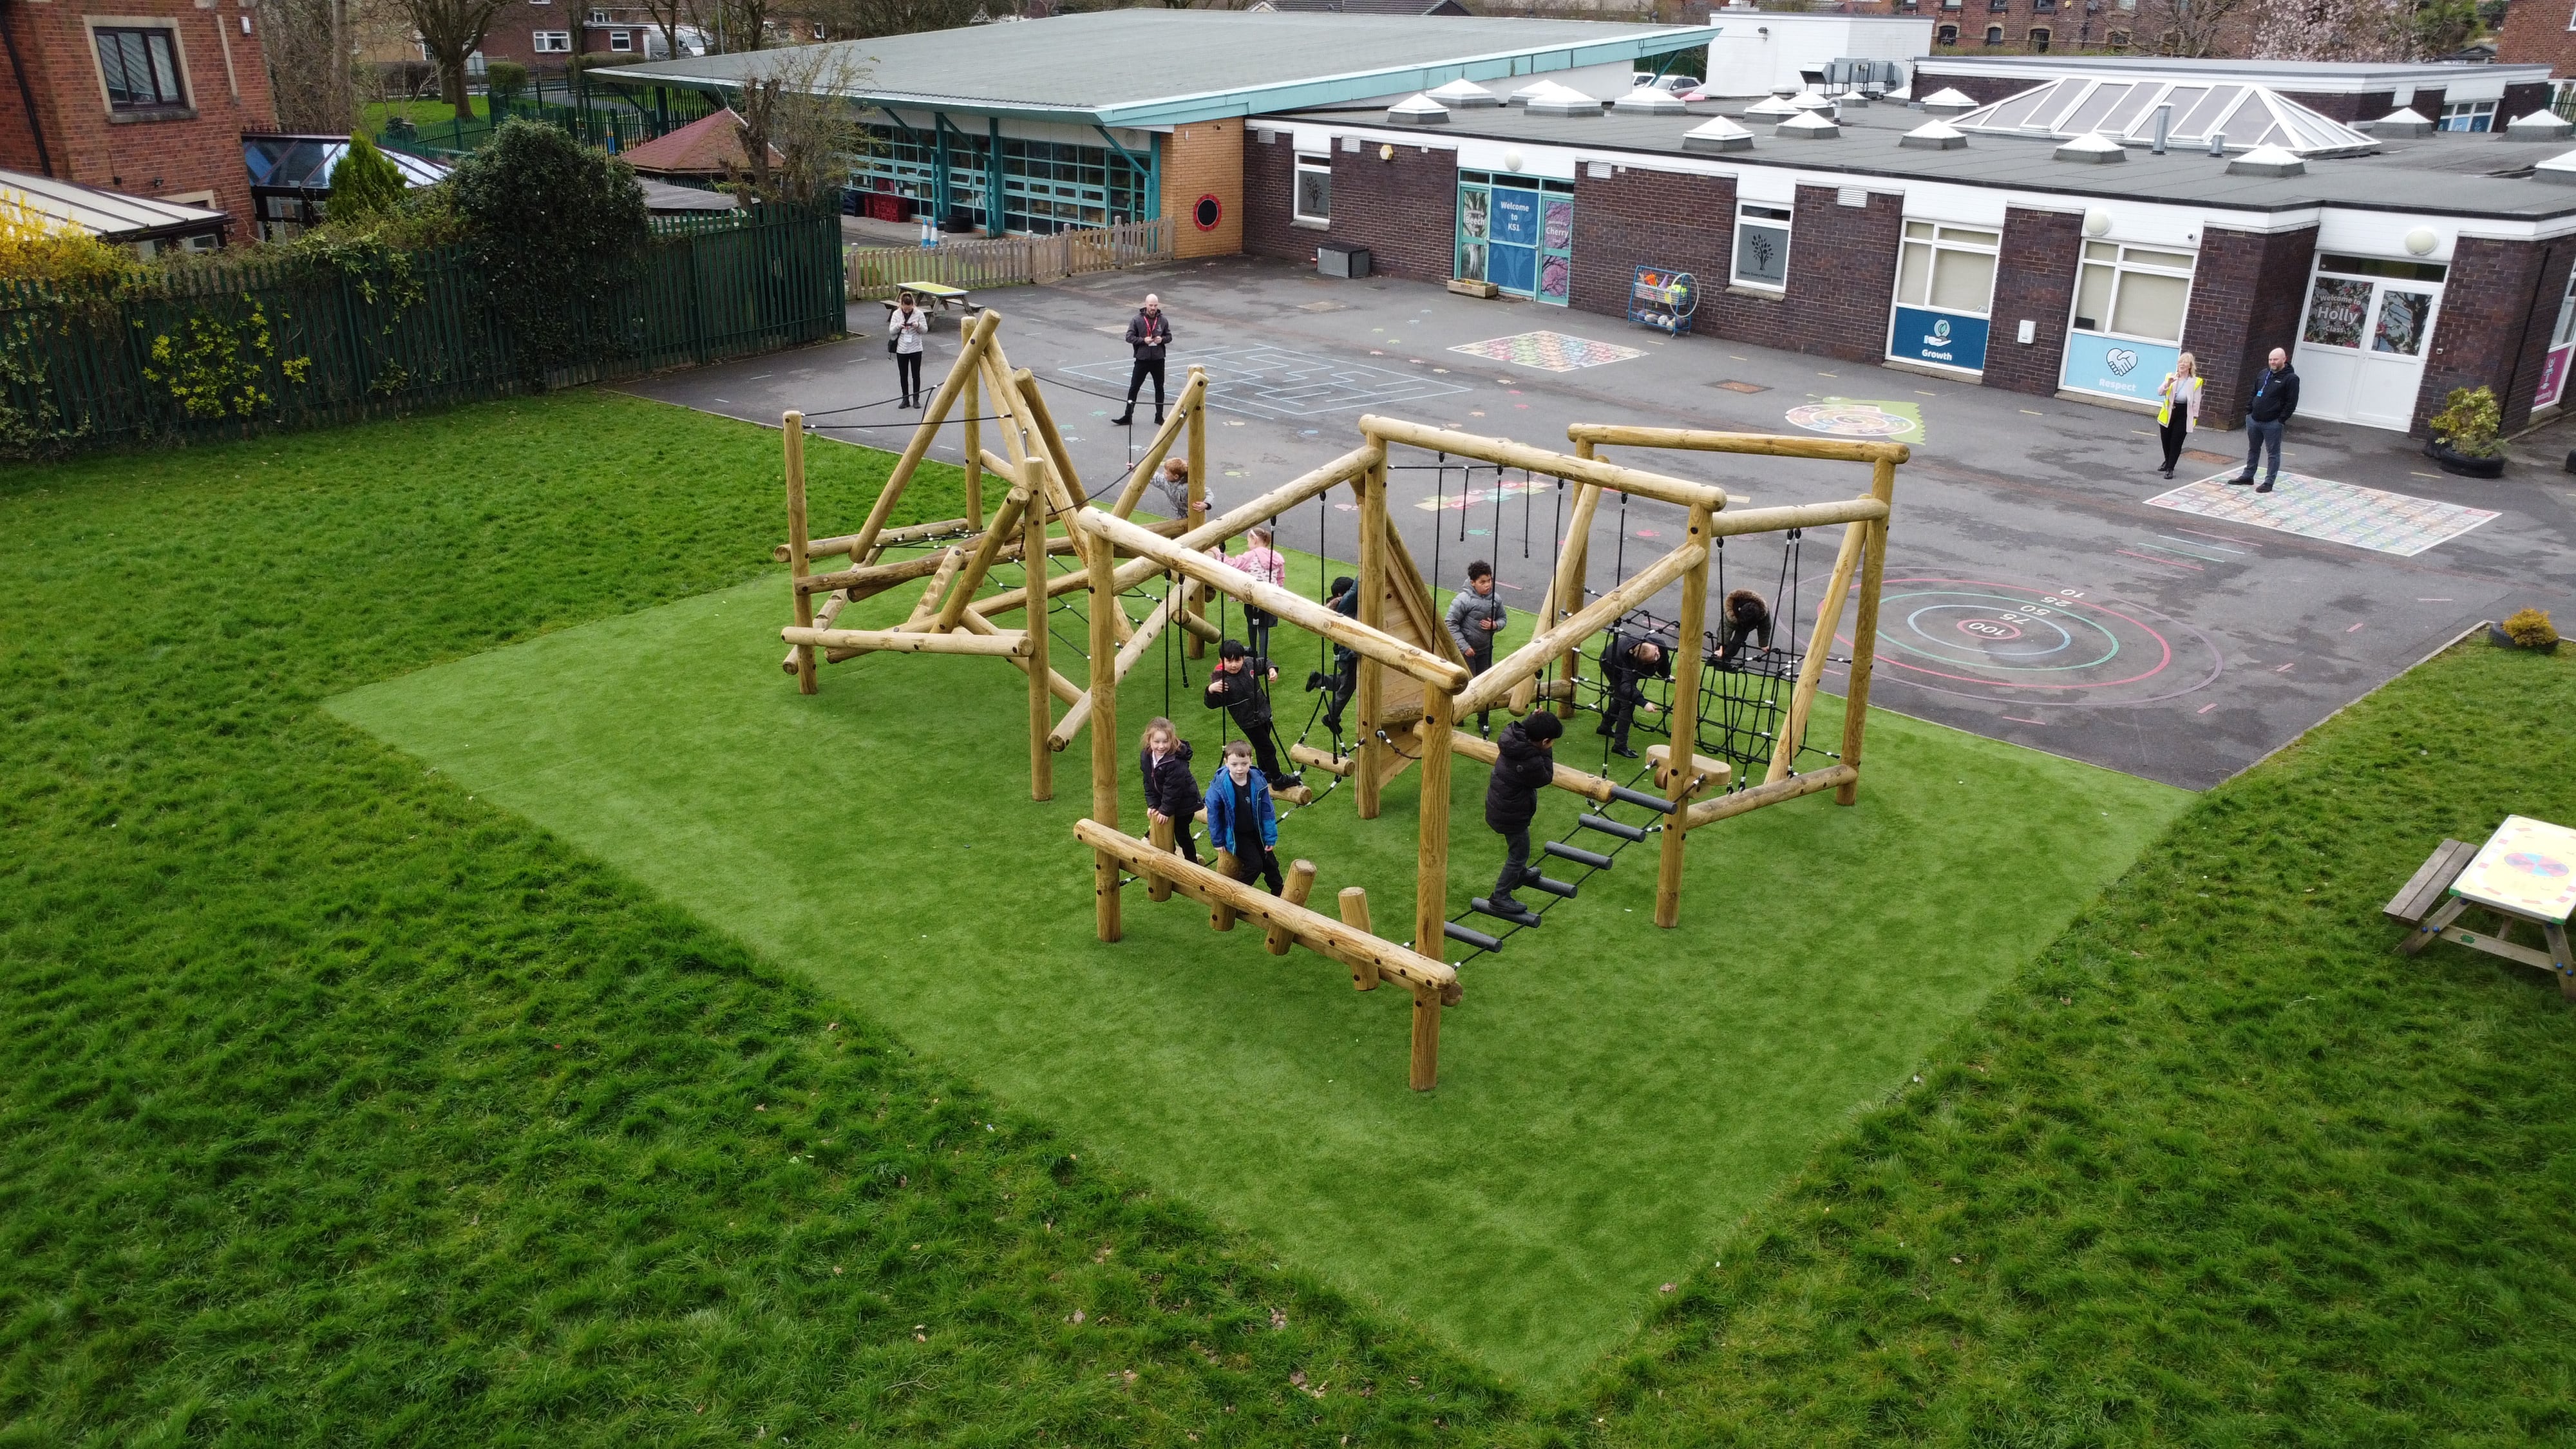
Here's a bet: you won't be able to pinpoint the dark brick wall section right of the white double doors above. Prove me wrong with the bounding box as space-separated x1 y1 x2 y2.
2411 237 2576 433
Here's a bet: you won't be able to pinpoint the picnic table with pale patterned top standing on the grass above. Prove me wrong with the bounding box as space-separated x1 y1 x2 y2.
2383 815 2576 1000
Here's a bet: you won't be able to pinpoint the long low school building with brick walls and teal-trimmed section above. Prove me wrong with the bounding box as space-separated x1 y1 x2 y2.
608 10 2576 431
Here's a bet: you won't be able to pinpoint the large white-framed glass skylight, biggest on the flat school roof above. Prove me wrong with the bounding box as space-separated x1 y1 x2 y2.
1950 75 2378 157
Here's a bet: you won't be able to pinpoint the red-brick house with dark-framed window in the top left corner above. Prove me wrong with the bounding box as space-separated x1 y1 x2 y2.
0 0 278 240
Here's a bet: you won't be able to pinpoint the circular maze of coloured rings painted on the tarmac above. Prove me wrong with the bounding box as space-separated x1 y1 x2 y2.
1837 578 2226 709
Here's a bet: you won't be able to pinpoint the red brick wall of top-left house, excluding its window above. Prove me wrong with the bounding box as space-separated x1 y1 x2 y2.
0 0 278 229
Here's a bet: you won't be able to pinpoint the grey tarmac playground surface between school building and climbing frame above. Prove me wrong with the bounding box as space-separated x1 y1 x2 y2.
629 258 2576 789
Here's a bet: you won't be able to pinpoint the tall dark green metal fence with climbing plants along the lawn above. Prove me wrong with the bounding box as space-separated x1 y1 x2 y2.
0 206 845 454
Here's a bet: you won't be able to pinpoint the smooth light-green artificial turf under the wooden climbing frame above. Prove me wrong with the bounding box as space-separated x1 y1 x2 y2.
332 531 2187 1390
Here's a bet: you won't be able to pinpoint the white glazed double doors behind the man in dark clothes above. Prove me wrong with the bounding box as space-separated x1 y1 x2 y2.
2298 255 2447 431
